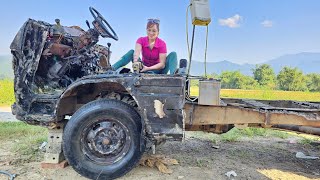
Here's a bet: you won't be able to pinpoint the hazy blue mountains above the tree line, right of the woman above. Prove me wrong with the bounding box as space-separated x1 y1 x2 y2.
190 52 320 76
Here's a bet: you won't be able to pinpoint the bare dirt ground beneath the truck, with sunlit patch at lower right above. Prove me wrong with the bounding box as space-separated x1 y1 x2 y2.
0 133 320 180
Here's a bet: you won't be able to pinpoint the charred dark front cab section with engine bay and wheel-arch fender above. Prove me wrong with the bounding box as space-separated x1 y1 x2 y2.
11 19 185 143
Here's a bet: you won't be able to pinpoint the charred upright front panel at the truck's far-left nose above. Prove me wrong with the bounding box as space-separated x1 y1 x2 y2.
10 19 48 116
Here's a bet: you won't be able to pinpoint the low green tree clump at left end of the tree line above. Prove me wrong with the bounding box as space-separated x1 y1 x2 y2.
220 71 258 89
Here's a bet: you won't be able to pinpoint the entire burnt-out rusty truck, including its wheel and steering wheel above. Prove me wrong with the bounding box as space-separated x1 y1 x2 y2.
10 7 320 179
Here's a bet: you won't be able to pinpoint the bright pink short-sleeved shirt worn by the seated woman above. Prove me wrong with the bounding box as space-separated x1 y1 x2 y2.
137 36 167 67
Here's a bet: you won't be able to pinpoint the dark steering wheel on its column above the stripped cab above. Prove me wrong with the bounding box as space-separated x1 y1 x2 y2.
89 7 119 41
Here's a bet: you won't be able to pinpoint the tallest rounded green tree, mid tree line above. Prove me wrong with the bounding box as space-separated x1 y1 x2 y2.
253 64 276 89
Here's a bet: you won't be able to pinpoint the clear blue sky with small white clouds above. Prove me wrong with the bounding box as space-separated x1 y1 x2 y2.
0 0 320 63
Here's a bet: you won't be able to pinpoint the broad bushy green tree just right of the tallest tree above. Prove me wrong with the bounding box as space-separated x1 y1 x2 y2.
277 66 308 91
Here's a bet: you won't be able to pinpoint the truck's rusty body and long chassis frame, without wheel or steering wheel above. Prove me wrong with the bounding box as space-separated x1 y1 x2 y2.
10 19 320 146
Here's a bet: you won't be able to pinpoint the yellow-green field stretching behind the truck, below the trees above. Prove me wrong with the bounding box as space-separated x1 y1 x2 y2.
0 79 320 106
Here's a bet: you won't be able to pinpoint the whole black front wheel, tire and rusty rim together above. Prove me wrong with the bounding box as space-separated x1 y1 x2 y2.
63 99 145 179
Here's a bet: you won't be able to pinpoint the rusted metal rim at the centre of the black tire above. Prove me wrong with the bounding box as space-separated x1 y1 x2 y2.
81 119 131 164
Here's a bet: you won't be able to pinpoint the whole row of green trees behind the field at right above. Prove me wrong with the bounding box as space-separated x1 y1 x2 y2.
206 64 320 92
